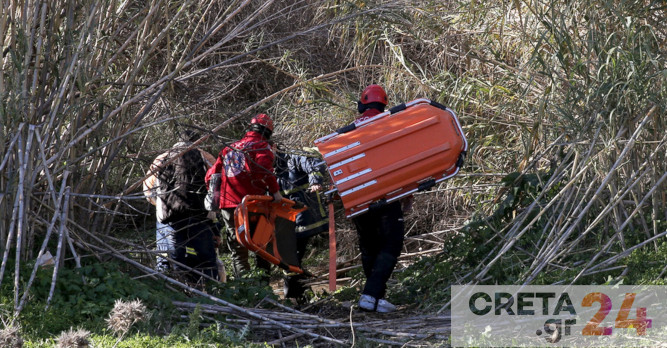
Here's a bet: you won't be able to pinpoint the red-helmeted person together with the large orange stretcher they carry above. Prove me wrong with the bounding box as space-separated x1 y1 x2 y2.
315 85 468 313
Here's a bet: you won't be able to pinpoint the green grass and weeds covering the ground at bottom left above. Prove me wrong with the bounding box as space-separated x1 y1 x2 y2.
0 263 271 347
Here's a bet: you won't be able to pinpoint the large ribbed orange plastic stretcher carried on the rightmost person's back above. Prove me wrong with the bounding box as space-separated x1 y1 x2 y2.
315 99 468 218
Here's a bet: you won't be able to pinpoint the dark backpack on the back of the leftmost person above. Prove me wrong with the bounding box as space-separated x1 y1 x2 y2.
157 149 207 223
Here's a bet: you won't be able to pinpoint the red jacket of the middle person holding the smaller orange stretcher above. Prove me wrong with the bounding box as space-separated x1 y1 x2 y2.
206 131 280 208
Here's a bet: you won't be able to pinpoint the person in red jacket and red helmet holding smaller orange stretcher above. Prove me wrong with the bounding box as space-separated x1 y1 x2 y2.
206 114 282 278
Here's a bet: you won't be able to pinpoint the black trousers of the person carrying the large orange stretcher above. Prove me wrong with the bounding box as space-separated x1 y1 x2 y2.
352 201 404 299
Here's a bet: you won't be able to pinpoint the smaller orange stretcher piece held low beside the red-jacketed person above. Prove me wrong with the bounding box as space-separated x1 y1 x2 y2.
234 195 307 273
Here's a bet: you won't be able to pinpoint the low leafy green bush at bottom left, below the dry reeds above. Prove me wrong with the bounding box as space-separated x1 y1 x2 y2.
1 263 178 338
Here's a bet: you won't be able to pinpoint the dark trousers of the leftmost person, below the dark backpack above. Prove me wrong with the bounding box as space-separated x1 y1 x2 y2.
169 217 218 283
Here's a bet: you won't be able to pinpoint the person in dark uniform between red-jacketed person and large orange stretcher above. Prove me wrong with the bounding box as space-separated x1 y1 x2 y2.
274 145 329 300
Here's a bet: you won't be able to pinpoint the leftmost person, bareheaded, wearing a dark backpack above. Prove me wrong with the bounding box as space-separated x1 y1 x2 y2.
143 131 220 284
